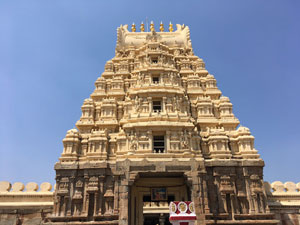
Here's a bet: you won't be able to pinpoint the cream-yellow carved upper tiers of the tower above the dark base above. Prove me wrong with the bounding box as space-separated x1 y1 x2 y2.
60 24 259 163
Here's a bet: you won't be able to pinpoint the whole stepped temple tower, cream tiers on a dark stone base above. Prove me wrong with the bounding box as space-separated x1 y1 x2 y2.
50 23 276 225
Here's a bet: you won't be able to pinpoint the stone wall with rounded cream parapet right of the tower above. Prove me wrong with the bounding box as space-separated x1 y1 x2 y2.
265 181 300 225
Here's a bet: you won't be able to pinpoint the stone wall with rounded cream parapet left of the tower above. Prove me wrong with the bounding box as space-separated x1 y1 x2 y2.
0 181 53 225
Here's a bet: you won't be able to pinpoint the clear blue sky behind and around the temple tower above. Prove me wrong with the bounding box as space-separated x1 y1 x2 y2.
0 0 300 183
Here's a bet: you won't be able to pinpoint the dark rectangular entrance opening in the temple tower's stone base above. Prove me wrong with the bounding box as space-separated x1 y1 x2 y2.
130 173 190 225
